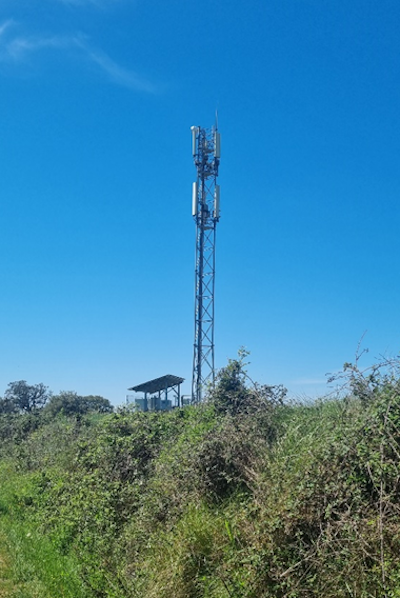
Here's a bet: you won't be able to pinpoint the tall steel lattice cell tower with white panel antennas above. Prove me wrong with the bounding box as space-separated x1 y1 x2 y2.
191 123 221 403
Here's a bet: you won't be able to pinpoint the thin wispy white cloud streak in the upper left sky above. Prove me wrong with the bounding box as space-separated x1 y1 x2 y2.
0 20 156 93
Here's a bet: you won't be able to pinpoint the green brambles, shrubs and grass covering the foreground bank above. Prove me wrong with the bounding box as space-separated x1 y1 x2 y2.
0 355 400 598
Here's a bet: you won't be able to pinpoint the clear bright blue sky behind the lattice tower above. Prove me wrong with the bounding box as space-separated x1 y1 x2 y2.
0 0 400 404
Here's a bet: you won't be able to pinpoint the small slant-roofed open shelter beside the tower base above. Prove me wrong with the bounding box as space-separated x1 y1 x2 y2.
128 374 184 411
